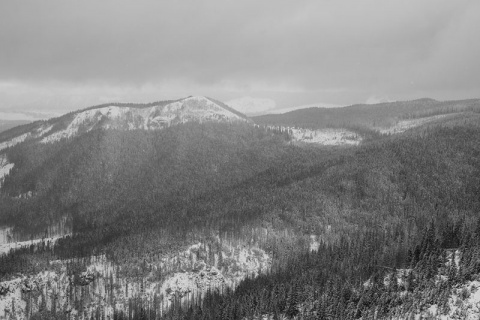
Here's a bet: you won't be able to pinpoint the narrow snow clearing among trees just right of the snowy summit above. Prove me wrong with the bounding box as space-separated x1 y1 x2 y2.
288 128 362 146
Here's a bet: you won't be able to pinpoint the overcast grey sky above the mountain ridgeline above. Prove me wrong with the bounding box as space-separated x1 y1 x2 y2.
0 0 480 114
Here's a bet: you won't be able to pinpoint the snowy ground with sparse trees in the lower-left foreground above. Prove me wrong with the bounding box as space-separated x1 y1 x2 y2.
0 239 271 319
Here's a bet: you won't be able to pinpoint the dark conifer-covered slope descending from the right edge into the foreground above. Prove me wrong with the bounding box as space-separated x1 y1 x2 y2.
155 124 480 319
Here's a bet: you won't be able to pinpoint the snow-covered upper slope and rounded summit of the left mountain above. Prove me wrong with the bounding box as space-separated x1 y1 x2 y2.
0 97 248 151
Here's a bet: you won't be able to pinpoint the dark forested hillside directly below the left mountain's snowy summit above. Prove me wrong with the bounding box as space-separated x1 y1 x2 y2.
2 123 288 230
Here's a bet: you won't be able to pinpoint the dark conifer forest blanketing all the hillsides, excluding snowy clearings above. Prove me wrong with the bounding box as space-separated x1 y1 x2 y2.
0 107 480 319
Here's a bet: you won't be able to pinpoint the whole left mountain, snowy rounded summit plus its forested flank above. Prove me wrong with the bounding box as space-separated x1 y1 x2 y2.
0 97 266 229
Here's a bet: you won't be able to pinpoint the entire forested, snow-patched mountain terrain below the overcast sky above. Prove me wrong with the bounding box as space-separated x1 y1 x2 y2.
0 97 480 319
